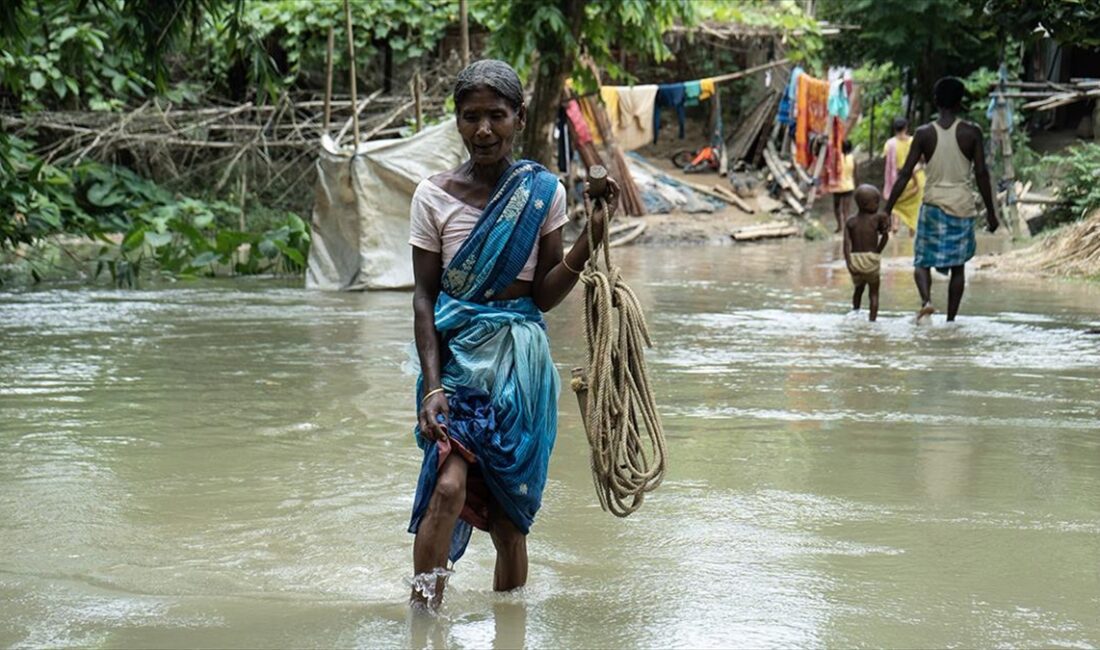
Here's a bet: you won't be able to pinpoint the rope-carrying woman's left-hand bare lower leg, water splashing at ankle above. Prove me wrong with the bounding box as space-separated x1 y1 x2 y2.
410 453 469 606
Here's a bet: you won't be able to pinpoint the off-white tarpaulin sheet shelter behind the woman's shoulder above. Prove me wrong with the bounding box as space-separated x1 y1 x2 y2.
306 119 468 291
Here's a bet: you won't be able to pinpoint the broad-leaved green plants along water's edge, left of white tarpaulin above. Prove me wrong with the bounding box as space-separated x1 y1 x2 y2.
0 135 309 285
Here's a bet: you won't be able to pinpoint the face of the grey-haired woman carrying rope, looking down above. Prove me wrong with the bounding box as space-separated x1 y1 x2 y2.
458 88 527 165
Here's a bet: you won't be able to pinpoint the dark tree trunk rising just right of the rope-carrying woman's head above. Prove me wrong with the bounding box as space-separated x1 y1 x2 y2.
523 0 584 167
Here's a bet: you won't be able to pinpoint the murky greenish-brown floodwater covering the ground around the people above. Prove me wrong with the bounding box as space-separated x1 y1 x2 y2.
0 241 1100 648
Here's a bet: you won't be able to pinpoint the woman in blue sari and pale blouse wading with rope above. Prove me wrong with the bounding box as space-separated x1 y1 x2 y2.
409 60 617 606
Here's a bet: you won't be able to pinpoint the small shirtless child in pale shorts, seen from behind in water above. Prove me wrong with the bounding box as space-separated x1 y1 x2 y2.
844 185 890 321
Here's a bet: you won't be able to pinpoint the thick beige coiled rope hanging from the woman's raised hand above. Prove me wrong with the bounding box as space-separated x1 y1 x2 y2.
571 193 668 517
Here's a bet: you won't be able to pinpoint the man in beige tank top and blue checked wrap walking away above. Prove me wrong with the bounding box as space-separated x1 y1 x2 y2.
883 77 999 321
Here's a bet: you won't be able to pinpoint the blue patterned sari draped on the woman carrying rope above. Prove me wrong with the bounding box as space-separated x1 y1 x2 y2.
409 161 560 562
